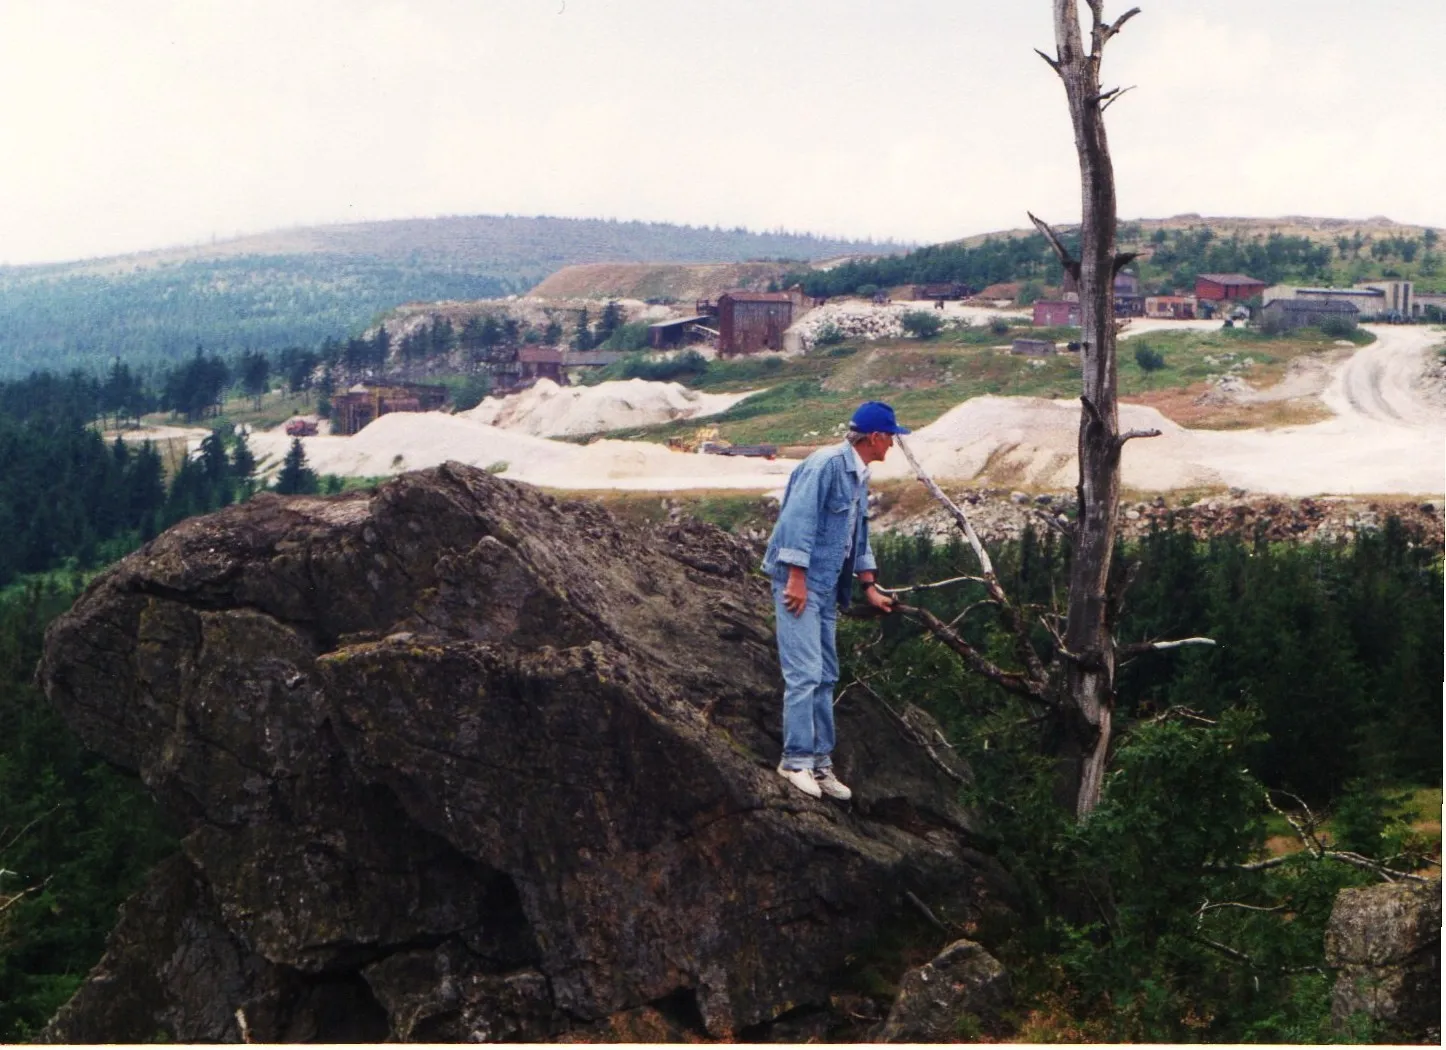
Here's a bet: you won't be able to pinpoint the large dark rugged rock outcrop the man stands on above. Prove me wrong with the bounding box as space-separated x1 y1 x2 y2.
39 464 1006 1041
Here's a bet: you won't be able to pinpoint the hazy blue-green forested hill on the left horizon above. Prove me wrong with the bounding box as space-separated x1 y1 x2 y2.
0 215 901 376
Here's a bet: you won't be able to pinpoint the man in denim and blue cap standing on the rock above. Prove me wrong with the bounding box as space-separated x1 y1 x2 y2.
763 401 908 800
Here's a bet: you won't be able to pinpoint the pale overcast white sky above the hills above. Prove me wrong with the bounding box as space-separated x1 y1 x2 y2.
0 0 1446 263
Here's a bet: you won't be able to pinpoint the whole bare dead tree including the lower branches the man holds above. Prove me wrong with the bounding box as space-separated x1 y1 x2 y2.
891 0 1215 819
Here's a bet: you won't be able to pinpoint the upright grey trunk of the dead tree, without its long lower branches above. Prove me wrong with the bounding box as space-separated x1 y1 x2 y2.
1030 0 1142 817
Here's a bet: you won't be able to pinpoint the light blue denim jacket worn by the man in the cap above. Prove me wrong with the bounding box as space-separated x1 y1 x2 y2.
763 441 878 605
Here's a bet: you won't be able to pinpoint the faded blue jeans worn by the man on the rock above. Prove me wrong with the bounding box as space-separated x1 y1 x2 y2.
774 577 839 769
